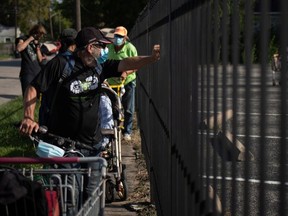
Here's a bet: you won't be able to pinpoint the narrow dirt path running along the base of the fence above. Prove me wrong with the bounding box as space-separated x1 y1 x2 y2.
104 129 157 216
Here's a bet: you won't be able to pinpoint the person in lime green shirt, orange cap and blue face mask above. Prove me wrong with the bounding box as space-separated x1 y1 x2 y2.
107 26 138 141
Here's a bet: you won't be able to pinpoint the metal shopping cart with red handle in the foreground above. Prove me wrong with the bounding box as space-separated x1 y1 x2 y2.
0 157 107 216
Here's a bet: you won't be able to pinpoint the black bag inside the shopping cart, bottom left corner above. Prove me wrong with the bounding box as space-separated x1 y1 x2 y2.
0 168 48 216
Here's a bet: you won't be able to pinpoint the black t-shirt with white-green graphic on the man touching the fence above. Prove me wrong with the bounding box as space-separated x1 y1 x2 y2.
32 53 121 144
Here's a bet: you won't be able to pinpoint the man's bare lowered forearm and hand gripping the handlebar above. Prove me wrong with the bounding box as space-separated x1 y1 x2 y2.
20 85 39 135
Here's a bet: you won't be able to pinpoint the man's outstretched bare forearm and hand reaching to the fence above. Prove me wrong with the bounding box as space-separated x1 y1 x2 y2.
118 44 160 72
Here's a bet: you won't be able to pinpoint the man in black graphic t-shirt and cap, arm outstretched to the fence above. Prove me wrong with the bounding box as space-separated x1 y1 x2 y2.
19 27 160 206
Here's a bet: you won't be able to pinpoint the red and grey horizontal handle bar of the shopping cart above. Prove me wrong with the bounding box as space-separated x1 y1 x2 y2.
0 157 103 164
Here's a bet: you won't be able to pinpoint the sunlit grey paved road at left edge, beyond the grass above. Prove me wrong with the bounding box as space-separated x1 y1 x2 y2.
0 59 21 105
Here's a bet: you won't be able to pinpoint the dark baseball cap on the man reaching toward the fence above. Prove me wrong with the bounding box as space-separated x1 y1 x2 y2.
75 27 112 48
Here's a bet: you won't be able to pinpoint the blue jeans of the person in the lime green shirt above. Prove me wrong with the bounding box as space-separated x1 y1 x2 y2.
122 79 136 134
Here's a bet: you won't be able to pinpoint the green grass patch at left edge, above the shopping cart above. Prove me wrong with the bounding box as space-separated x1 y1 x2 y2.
0 97 39 157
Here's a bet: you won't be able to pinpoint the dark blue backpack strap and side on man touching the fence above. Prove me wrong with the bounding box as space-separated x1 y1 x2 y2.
39 51 75 125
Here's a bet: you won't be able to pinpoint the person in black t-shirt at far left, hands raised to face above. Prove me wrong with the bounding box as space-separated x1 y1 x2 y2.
15 24 46 96
